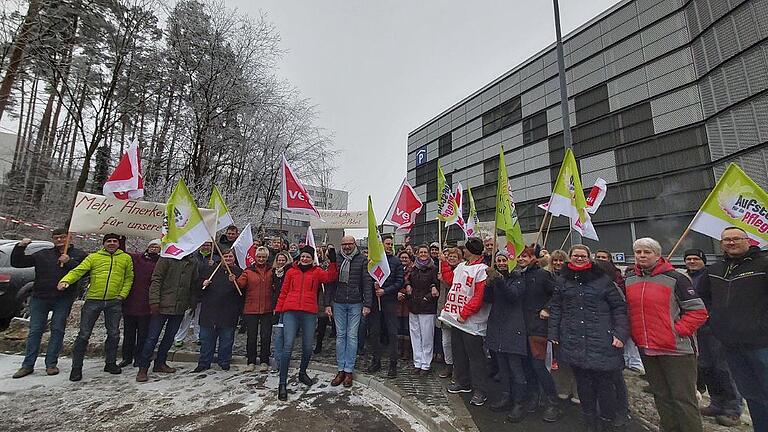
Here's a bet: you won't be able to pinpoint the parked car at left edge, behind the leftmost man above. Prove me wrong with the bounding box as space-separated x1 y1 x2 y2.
0 240 53 330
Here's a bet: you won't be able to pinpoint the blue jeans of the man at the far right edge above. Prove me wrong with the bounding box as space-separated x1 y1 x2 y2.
725 347 768 432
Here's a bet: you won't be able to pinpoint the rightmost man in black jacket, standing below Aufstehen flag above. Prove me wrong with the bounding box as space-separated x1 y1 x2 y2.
701 227 768 431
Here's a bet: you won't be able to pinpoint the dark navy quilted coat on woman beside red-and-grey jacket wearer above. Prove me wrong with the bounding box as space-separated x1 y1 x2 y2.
549 266 629 371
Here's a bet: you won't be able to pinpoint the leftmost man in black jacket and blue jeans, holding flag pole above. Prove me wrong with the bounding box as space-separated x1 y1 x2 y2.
11 229 85 378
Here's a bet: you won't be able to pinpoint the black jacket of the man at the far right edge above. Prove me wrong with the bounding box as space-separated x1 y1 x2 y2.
699 246 768 349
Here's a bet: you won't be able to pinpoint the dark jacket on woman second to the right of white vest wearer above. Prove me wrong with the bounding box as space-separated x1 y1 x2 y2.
513 264 555 337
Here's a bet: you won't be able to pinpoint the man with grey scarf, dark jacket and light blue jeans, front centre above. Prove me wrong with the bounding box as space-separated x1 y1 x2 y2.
324 236 373 387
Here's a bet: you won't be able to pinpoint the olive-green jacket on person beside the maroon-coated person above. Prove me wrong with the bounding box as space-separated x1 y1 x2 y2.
149 254 200 315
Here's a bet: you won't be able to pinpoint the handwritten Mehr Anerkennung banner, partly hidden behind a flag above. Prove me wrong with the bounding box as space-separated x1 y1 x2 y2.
69 192 216 239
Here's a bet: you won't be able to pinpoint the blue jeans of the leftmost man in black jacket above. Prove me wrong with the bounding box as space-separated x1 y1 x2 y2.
21 297 73 369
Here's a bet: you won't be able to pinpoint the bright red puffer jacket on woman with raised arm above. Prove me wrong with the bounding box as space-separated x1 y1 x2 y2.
275 262 339 313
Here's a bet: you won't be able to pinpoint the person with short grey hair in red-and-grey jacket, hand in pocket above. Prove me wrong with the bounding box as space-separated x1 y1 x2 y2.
626 237 707 432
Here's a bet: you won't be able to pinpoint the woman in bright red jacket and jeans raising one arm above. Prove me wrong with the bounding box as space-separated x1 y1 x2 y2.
275 246 339 401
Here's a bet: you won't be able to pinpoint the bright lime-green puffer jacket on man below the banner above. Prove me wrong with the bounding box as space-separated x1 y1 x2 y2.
61 248 133 300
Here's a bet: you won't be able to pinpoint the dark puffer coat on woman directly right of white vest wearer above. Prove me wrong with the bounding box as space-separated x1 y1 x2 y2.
483 271 528 356
